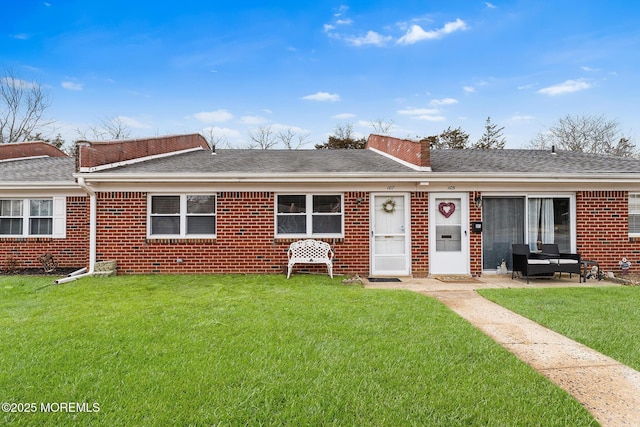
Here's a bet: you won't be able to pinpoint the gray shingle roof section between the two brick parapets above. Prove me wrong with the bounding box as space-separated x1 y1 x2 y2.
108 149 415 174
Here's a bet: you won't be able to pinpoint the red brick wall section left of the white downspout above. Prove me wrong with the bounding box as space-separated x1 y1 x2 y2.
0 196 89 270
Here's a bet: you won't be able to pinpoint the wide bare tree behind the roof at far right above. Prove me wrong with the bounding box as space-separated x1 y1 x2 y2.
529 115 638 157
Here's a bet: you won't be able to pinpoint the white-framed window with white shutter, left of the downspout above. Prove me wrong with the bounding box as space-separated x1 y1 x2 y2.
0 197 66 237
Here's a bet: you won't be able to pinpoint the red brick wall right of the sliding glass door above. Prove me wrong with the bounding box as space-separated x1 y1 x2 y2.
576 191 640 273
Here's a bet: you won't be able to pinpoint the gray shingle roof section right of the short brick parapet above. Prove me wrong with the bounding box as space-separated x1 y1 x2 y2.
431 150 640 175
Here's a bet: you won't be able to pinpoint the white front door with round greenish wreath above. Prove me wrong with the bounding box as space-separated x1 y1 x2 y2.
370 193 411 276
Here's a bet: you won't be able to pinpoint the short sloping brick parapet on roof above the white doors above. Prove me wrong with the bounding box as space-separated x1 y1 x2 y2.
366 134 431 171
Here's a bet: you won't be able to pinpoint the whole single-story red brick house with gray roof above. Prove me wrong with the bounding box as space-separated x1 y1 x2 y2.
0 134 640 276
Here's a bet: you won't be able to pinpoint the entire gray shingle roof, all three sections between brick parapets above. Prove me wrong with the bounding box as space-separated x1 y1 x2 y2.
0 149 640 184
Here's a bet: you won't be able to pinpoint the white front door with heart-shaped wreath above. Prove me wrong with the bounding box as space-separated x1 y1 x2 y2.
429 193 469 275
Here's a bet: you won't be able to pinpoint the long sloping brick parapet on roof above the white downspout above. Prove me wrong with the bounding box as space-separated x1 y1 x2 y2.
76 133 210 171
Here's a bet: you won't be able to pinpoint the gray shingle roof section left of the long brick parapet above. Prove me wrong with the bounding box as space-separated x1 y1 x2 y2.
0 157 75 184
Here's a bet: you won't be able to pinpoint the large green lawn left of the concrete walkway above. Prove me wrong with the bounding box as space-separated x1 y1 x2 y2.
0 275 596 426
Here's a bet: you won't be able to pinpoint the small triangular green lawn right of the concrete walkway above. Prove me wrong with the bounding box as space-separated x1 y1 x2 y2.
479 286 640 371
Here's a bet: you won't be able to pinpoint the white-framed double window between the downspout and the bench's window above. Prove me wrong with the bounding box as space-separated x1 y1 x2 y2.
148 194 216 237
